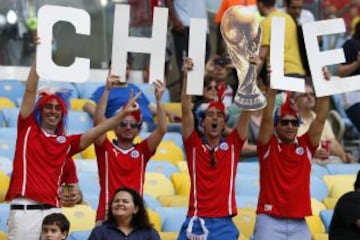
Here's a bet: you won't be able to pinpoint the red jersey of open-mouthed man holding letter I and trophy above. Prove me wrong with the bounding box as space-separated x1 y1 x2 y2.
184 129 244 217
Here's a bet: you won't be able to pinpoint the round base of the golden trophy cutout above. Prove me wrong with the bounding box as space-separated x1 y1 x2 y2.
234 93 267 111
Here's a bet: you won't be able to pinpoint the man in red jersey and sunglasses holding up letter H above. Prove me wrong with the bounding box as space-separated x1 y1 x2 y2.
94 72 166 221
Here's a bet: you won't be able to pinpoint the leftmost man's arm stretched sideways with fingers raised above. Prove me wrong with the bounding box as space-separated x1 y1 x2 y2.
80 92 141 150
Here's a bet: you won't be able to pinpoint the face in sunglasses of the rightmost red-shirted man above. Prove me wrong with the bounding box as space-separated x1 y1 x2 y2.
275 115 299 143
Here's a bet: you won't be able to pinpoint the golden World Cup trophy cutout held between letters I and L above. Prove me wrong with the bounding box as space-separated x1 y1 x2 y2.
220 6 266 110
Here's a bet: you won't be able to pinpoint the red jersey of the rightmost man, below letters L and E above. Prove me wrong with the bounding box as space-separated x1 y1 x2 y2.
257 134 317 218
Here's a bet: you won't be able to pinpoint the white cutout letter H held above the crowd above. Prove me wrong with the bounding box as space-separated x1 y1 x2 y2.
111 4 168 83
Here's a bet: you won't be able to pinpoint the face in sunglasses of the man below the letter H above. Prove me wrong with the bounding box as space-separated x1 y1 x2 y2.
115 115 139 141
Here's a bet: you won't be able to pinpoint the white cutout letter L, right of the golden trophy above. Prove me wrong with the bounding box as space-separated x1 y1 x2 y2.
270 17 305 92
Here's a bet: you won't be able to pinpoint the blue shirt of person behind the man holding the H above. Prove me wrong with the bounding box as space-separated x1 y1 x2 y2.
90 83 154 123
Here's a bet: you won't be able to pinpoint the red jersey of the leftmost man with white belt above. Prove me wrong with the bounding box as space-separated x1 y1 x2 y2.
5 114 81 207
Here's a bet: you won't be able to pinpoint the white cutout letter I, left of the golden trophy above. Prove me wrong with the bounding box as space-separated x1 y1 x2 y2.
187 18 207 96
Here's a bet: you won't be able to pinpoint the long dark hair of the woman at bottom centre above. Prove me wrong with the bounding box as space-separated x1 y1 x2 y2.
106 187 153 229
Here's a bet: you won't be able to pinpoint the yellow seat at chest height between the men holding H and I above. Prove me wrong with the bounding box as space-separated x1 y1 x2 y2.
151 141 184 165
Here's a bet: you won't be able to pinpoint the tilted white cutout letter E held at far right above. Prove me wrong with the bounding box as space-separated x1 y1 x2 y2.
303 18 360 97
